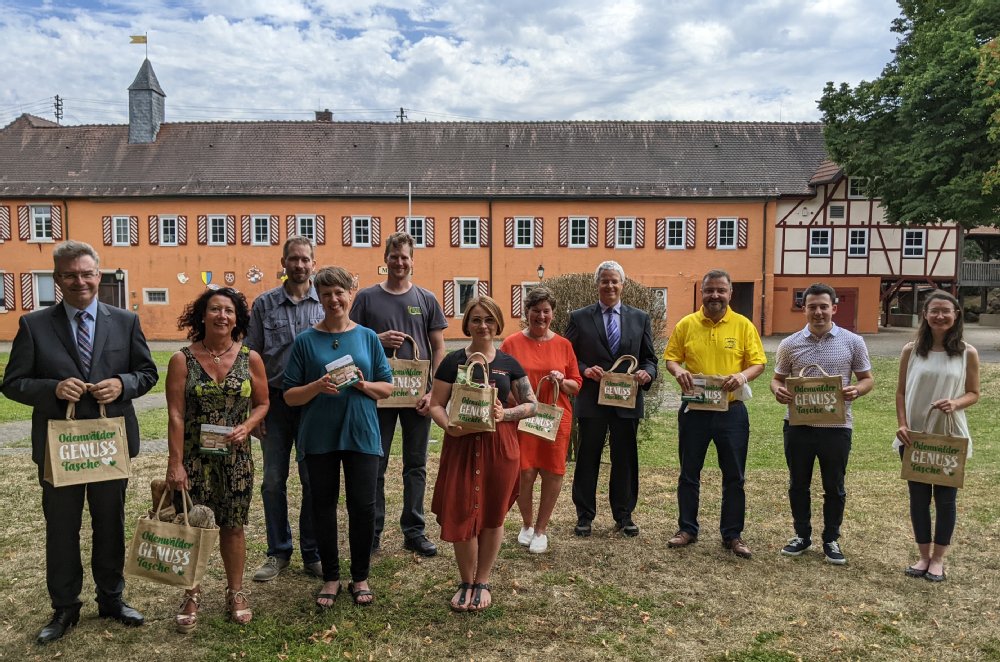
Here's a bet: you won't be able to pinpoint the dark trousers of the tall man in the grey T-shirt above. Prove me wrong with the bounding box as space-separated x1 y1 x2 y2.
374 407 431 547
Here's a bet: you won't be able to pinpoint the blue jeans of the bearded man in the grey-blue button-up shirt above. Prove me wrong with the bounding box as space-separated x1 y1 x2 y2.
260 388 319 563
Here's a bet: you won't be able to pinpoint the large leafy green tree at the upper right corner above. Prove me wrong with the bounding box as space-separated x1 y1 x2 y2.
819 0 1000 226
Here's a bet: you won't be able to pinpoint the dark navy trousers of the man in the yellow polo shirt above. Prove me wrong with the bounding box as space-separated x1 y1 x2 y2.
677 400 750 541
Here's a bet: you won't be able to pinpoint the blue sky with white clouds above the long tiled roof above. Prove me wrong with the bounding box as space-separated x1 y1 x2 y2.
0 0 899 126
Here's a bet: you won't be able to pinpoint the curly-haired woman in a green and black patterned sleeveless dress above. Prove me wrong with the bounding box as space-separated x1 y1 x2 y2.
167 287 268 633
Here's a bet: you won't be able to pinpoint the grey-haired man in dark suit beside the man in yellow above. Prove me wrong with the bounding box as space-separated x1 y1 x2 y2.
566 260 656 536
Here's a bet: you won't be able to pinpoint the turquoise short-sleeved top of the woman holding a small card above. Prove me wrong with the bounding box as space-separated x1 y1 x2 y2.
284 325 392 461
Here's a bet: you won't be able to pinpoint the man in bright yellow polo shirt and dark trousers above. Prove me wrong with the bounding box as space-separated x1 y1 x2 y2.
663 269 767 559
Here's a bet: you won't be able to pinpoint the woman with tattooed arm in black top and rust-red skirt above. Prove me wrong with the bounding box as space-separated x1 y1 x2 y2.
431 297 535 611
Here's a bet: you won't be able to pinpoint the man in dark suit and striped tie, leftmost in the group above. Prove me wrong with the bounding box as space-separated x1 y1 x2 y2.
0 241 157 643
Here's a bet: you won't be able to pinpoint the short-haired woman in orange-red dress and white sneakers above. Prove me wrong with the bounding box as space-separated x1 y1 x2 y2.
500 287 583 554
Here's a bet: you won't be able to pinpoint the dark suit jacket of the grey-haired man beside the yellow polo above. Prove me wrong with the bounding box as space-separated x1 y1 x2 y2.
566 303 656 418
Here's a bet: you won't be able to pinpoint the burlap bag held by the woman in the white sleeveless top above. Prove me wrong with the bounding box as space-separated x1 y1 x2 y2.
899 409 969 487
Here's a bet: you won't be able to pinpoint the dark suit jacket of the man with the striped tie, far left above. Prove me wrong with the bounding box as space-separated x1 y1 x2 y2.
0 303 159 466
